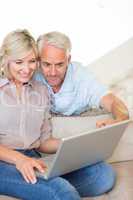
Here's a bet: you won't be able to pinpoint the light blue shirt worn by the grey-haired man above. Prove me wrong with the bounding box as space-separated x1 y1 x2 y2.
35 62 108 115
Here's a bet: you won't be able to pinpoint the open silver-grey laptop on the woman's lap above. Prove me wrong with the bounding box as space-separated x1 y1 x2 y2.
37 120 131 179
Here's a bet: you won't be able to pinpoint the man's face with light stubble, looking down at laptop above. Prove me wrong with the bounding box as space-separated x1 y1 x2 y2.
41 45 70 93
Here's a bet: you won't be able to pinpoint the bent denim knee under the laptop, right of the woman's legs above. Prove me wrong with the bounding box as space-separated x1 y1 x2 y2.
62 162 116 197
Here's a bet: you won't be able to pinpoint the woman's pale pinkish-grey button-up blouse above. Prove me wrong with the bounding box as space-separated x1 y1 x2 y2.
0 79 52 149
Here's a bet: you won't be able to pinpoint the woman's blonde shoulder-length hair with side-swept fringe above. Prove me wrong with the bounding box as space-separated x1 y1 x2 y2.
0 29 38 78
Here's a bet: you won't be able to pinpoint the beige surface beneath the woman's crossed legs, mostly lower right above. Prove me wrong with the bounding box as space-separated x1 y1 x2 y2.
0 161 133 200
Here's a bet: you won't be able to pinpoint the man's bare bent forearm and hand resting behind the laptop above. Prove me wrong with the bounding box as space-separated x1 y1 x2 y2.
96 93 129 127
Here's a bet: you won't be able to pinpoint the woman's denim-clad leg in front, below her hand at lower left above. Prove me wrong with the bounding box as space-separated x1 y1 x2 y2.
0 151 80 200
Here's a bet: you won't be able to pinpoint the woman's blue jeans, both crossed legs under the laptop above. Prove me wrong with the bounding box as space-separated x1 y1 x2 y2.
0 150 115 200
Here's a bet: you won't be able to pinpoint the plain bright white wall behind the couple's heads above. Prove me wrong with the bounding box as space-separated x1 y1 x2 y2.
0 0 133 64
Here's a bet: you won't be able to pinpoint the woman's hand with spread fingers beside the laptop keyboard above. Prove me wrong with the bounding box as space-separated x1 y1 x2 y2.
16 156 47 184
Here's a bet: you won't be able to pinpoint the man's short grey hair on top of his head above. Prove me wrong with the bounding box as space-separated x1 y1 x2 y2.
37 31 72 55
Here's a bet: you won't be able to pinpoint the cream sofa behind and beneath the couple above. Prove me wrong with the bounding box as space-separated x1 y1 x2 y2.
0 38 133 200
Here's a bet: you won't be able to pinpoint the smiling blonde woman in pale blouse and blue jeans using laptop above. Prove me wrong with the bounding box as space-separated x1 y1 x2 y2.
0 30 80 200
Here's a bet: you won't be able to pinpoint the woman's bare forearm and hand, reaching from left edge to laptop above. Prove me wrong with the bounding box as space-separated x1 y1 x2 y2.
0 145 46 184
